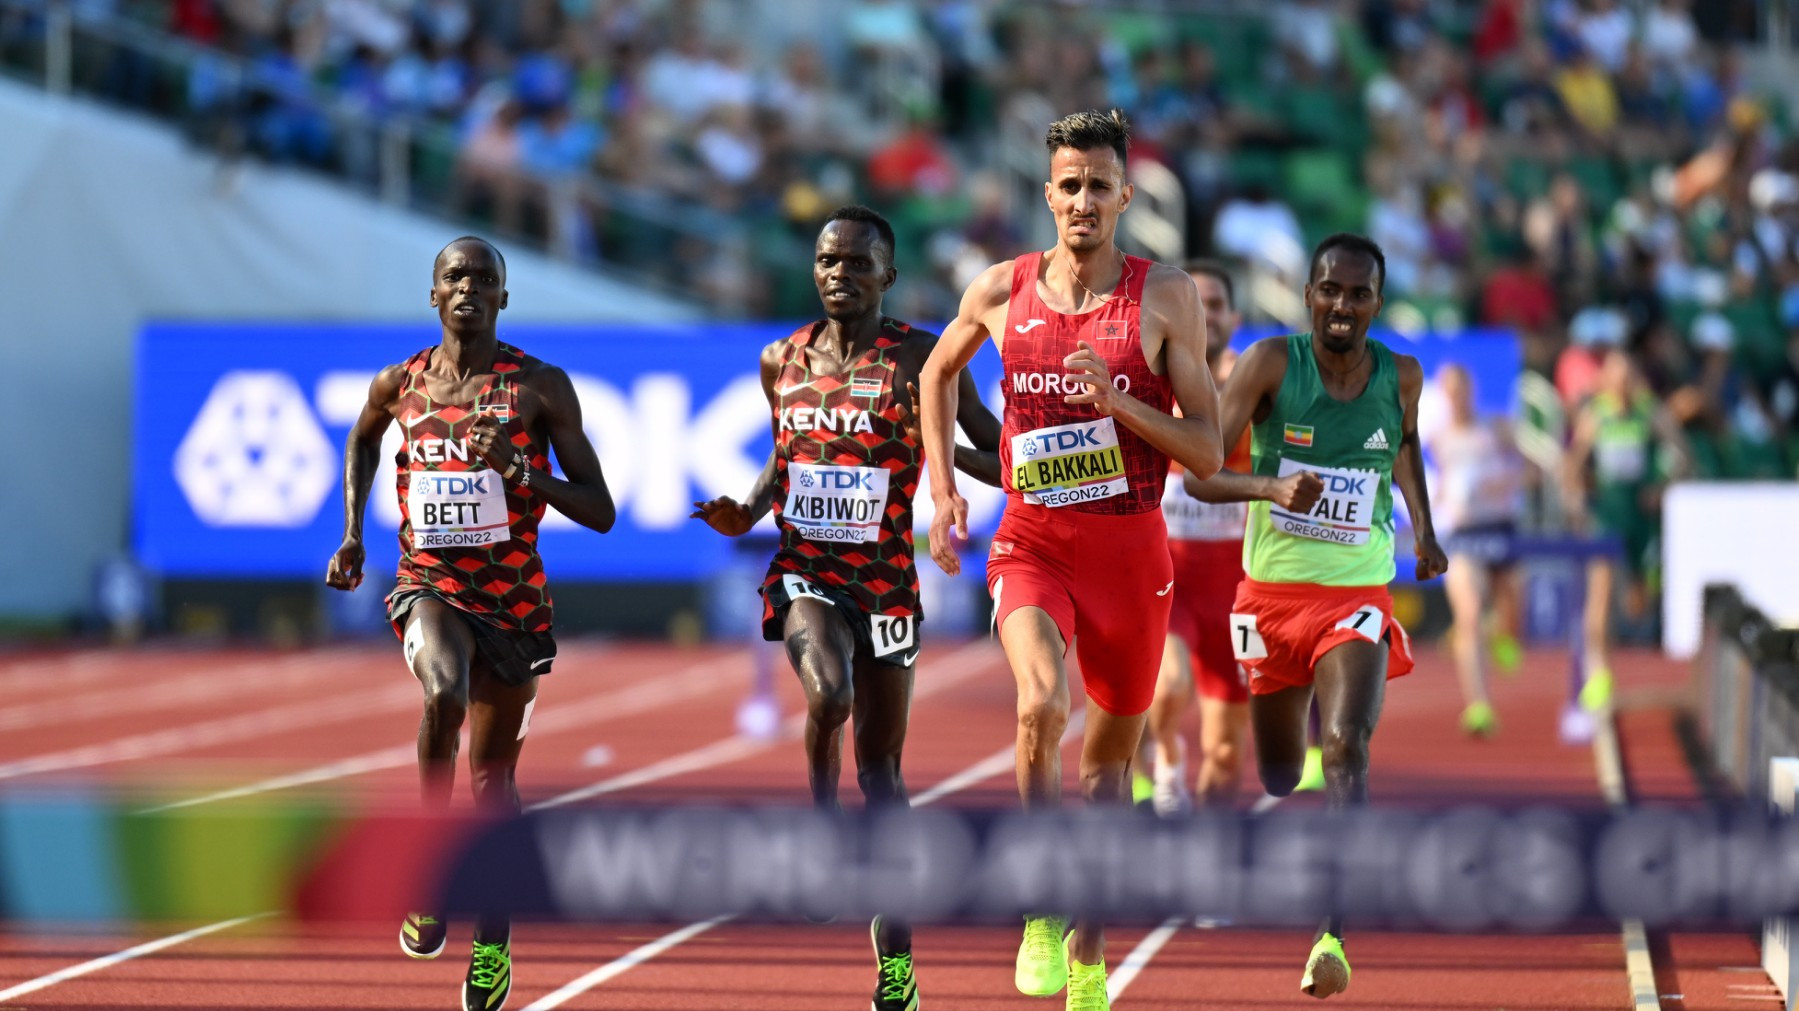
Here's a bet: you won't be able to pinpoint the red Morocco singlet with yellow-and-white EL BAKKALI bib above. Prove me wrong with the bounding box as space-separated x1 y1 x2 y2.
1000 252 1175 516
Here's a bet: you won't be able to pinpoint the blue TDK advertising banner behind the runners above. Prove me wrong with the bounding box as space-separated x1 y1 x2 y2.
133 322 1518 581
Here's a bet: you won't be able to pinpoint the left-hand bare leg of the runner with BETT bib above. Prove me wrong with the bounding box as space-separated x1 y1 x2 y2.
405 597 475 808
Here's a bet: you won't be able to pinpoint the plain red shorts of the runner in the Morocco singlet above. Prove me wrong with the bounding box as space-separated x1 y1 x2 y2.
988 498 1175 716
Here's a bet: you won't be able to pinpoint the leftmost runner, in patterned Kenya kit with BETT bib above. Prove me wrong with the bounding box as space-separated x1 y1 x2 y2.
326 237 617 1011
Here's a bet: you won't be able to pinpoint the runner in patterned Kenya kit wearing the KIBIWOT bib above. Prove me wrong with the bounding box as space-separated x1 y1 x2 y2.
693 207 1000 1011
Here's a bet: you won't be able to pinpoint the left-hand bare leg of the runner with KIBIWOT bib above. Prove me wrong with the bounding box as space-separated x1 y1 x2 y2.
781 597 856 810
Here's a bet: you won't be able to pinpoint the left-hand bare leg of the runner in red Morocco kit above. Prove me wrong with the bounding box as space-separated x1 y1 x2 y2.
1000 606 1065 808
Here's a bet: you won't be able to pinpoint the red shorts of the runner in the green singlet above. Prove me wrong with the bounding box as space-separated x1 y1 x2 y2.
1231 579 1412 694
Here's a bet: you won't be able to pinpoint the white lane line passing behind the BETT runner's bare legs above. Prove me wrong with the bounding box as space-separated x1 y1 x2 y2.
144 655 743 813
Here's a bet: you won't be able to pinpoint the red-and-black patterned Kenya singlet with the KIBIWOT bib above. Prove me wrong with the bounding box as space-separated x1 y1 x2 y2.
763 318 925 615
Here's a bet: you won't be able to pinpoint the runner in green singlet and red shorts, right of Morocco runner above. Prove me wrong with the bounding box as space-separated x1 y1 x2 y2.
1194 234 1448 997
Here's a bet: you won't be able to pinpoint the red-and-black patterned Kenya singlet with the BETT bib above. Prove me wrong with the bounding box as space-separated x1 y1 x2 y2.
389 344 552 631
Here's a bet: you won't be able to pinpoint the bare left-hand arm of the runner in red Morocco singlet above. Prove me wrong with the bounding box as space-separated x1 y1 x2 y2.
917 259 1013 576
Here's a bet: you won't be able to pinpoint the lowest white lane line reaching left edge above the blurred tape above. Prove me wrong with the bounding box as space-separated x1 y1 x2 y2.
0 684 417 779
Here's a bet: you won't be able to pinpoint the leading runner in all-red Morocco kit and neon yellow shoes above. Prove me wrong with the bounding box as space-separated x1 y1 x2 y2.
919 110 1223 1011
